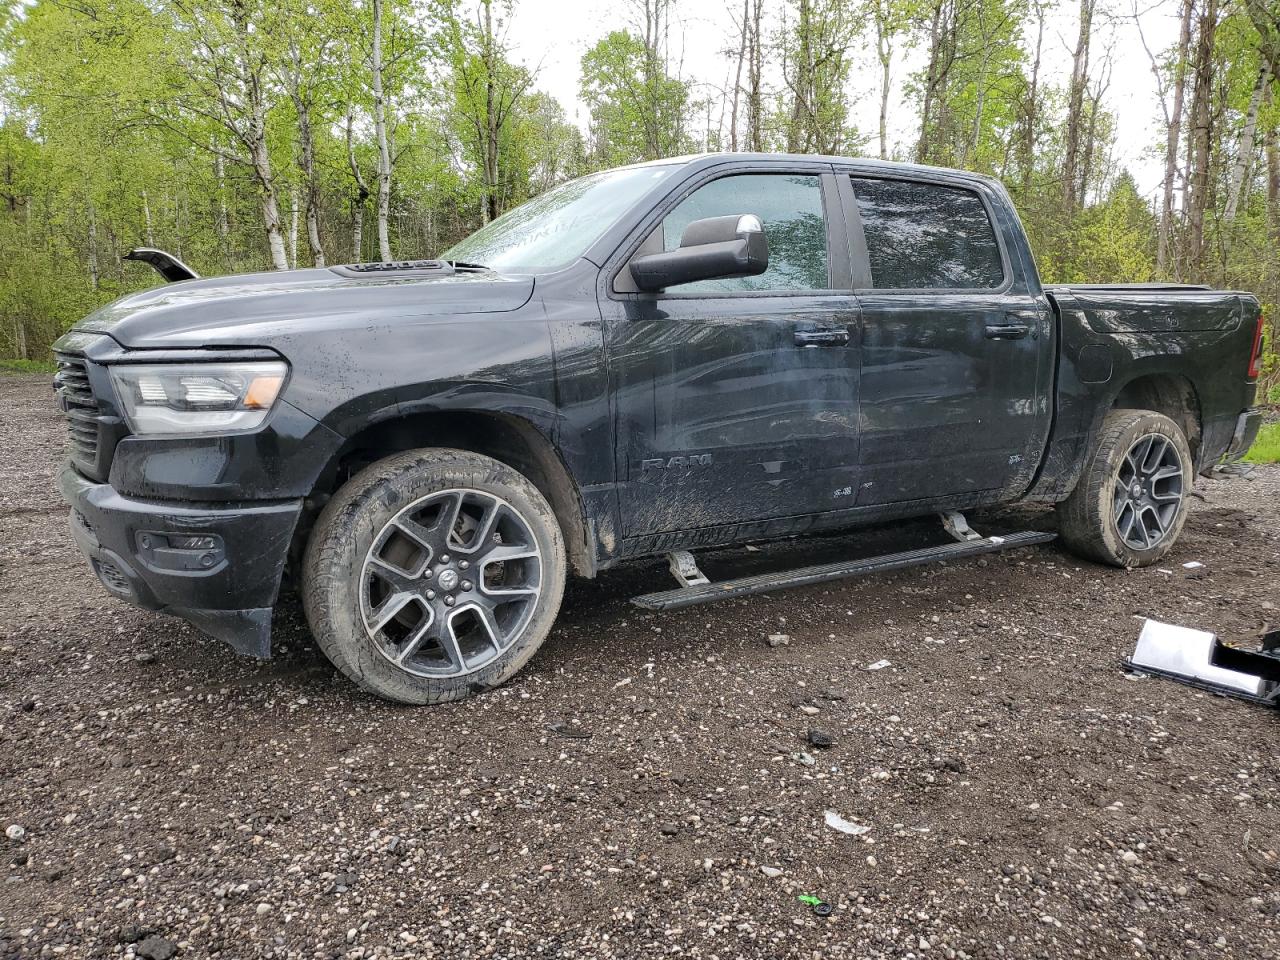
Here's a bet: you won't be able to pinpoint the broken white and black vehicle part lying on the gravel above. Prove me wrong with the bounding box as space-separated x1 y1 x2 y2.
1124 618 1280 707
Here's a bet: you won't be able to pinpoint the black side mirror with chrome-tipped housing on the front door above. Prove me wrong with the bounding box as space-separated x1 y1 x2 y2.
631 214 769 293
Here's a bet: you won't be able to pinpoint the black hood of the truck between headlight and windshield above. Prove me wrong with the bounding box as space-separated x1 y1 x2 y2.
72 268 534 348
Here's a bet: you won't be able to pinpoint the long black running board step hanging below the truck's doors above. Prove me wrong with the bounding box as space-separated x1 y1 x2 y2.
631 530 1057 611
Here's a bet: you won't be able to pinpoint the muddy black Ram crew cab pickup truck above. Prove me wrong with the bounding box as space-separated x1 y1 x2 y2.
55 154 1262 703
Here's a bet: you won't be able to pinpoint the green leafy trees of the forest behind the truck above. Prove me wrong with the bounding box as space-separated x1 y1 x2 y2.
0 0 1280 402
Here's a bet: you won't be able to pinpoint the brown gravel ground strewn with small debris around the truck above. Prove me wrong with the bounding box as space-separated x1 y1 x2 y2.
0 376 1280 960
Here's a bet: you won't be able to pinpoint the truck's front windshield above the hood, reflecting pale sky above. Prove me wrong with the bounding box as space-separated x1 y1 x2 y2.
440 164 676 273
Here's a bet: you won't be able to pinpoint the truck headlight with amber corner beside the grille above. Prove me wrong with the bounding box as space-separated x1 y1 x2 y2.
111 361 288 434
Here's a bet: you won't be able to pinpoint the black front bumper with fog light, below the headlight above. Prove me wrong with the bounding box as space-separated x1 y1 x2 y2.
59 463 302 658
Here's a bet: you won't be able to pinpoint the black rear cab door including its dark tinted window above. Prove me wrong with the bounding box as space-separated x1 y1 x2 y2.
841 174 1052 504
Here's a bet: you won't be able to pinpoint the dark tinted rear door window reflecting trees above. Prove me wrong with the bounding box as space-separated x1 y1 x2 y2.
851 177 1006 291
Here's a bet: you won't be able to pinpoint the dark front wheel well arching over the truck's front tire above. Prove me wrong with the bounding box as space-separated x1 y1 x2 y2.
294 411 595 576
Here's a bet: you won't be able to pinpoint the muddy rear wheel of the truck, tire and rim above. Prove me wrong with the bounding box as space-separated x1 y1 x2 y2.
1057 410 1196 567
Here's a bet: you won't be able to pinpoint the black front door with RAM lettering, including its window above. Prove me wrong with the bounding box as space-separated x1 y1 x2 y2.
602 164 859 538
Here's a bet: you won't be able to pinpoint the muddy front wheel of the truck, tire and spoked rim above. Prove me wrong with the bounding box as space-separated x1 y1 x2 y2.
302 448 566 704
